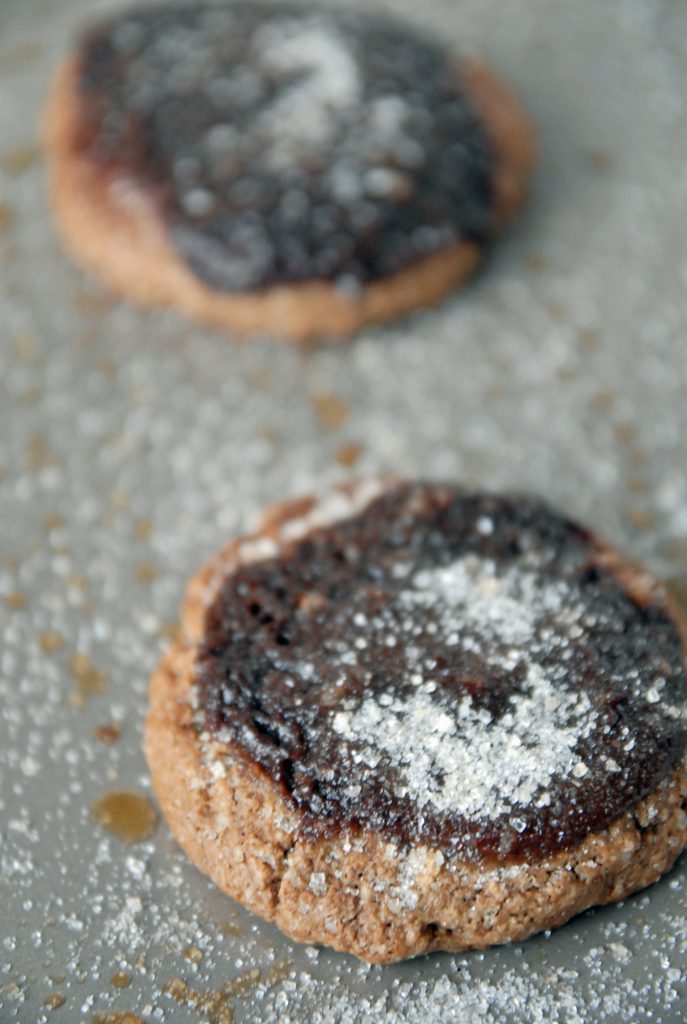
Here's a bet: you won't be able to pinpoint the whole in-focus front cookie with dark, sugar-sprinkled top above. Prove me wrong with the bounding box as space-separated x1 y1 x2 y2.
145 480 687 963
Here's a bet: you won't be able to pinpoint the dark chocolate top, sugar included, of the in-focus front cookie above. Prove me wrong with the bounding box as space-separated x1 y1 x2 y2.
196 483 687 861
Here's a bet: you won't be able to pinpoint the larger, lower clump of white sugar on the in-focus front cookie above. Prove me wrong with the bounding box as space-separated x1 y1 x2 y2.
333 667 594 819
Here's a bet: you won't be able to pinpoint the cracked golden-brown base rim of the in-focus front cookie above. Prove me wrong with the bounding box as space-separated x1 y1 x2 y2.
145 484 687 964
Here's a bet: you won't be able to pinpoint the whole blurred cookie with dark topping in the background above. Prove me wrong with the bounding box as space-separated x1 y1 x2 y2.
45 2 533 339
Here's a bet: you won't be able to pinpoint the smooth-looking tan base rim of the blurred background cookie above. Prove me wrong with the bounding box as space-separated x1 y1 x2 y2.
45 61 533 341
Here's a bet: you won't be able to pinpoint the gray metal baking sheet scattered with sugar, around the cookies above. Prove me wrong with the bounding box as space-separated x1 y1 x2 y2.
0 0 687 1024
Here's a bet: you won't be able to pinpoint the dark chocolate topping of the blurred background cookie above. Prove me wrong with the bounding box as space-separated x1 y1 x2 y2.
73 2 493 292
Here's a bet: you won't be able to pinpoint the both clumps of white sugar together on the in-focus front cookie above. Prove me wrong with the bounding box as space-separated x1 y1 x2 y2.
333 555 595 819
